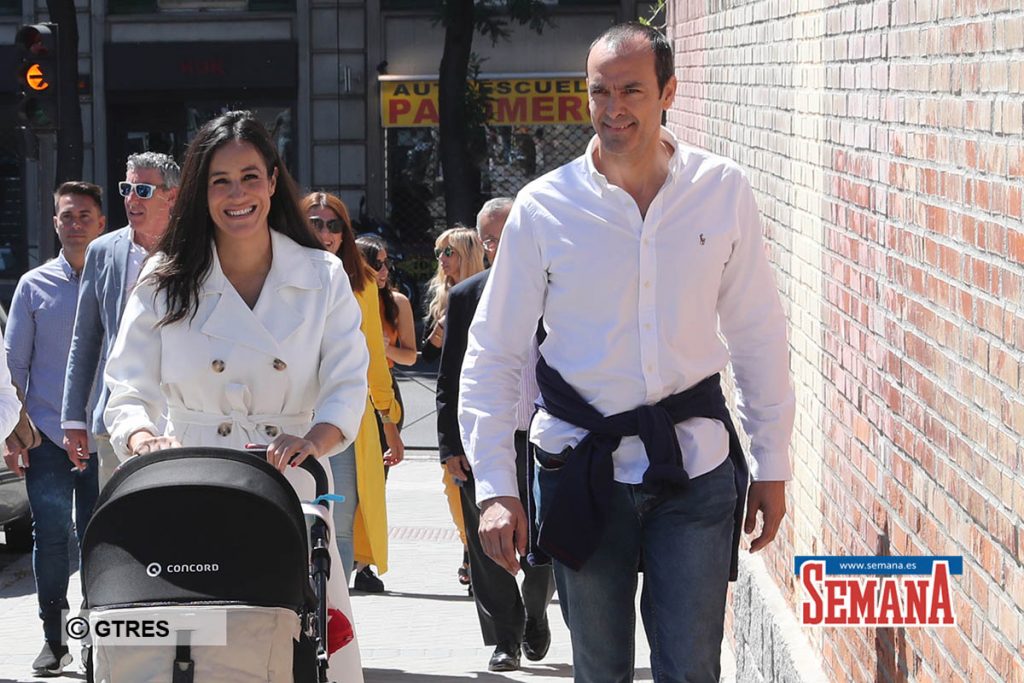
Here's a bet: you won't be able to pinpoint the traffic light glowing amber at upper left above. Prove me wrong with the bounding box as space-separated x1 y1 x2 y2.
15 24 60 131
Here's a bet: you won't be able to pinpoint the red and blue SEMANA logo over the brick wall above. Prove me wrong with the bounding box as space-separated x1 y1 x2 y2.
795 556 964 628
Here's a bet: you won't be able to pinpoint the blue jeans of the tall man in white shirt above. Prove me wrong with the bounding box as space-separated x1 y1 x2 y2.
536 451 736 683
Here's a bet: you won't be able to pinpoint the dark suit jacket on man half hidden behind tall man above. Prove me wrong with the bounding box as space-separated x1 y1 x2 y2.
437 270 490 463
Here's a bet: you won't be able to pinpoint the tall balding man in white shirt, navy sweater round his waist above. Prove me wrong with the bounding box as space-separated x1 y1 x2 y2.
459 24 796 683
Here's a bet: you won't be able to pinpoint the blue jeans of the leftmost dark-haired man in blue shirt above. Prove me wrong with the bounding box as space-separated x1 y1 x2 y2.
25 436 99 642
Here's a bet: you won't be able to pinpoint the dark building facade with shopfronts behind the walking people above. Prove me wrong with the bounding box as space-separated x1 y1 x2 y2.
0 0 646 299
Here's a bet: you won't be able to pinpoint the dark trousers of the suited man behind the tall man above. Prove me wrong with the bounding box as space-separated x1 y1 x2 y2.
461 431 555 645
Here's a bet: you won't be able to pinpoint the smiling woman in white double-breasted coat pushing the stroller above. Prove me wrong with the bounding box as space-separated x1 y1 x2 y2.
104 112 369 683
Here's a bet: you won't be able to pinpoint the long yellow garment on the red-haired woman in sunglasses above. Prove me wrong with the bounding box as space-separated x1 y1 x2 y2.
352 279 401 573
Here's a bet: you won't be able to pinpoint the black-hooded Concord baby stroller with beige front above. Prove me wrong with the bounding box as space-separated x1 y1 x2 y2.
82 449 331 683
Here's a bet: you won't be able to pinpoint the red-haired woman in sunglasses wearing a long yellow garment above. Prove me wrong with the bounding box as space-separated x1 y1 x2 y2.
300 193 406 593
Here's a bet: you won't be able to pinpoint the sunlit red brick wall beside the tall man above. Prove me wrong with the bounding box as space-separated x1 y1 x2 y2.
668 0 1024 683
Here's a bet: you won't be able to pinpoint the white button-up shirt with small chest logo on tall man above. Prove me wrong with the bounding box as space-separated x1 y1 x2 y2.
459 129 796 502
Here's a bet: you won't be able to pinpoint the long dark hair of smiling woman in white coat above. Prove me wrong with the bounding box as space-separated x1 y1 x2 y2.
150 112 324 327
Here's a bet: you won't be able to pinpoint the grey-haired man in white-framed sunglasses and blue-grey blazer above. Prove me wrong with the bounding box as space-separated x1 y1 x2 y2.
60 152 181 487
